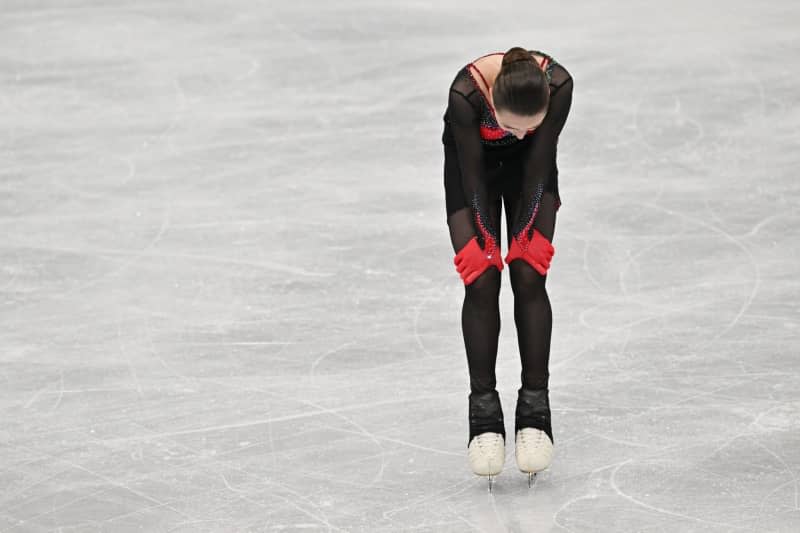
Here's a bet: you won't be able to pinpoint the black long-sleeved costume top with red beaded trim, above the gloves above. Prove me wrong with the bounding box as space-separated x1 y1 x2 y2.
442 50 573 256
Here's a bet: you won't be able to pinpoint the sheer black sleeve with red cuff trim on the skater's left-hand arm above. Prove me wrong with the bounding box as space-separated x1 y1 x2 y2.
447 85 499 252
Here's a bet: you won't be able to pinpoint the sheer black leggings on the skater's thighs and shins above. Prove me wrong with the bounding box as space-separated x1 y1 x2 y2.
445 150 556 393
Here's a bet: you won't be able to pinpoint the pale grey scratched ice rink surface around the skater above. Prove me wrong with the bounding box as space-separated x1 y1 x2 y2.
0 0 800 533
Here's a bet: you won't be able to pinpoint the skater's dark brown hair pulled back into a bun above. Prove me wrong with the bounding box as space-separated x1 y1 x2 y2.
492 46 550 117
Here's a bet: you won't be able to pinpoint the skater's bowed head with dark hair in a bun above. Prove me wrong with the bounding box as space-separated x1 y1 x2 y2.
489 46 550 139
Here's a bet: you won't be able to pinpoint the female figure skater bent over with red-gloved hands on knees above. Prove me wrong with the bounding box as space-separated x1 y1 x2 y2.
442 47 572 491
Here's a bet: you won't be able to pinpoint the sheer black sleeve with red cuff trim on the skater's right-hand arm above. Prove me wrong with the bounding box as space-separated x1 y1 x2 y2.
512 71 573 242
